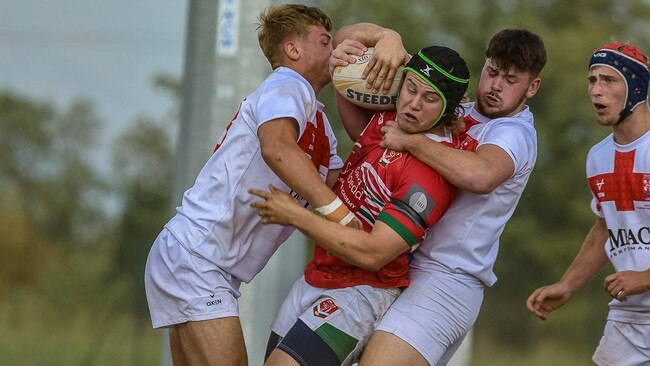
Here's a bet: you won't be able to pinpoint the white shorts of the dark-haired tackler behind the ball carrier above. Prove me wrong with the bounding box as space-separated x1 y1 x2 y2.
376 261 484 365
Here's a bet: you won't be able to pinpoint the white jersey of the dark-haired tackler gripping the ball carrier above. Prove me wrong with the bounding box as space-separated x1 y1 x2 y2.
414 102 537 286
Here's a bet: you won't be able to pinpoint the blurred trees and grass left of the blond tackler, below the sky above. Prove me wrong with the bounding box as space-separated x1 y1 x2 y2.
0 75 180 365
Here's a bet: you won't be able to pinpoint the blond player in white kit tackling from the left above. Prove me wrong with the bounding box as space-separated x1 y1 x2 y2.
145 4 398 365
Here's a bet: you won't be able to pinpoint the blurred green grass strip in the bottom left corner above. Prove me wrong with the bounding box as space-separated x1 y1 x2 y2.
0 298 162 366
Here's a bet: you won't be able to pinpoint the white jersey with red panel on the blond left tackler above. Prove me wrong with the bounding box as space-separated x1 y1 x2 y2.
166 67 343 282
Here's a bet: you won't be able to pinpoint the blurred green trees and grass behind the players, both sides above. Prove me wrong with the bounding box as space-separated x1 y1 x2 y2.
0 0 650 365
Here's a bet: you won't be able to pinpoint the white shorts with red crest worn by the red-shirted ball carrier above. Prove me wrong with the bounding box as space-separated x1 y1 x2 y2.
271 276 400 365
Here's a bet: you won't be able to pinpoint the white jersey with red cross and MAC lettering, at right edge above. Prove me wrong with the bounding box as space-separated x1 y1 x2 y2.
587 131 650 314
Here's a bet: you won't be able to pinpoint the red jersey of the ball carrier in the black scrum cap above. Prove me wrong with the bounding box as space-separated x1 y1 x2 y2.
305 111 460 288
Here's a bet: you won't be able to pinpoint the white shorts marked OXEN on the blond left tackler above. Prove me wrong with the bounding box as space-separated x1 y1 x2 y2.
144 228 241 328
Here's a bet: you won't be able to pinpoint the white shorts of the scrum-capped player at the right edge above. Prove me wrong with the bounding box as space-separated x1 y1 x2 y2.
592 320 650 366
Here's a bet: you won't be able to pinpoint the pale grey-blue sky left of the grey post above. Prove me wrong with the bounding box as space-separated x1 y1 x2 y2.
0 0 187 160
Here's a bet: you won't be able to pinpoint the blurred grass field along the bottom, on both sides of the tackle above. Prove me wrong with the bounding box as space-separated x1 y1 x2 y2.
0 286 595 366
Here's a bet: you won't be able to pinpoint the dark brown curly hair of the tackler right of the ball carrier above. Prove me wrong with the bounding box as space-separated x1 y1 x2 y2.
485 29 546 77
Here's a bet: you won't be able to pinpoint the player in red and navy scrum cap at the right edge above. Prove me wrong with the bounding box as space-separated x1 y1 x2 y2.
526 42 650 366
